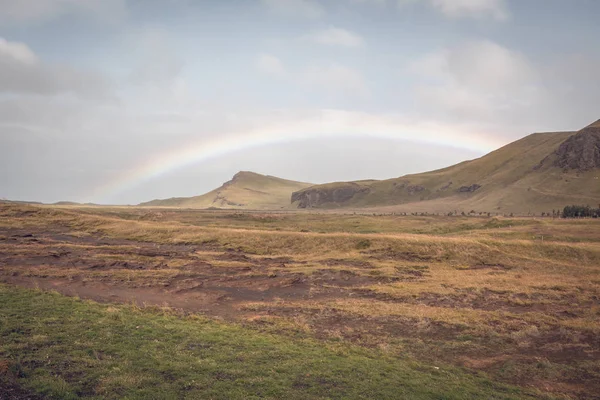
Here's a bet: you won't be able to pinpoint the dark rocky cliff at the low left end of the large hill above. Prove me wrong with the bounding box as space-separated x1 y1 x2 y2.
292 183 370 208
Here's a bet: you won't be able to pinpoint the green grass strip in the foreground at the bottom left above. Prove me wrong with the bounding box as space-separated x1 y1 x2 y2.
0 286 537 399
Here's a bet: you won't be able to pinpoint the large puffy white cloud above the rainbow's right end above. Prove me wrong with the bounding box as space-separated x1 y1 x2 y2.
409 40 543 123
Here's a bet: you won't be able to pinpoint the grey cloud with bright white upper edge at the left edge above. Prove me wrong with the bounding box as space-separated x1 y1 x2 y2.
0 38 110 98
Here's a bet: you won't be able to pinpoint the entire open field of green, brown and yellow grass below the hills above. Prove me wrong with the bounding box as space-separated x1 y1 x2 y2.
0 205 600 399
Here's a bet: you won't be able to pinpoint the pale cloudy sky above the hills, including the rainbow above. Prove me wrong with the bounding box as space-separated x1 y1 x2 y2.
0 0 600 204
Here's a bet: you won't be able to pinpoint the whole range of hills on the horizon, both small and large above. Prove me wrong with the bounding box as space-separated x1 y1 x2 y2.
140 120 600 215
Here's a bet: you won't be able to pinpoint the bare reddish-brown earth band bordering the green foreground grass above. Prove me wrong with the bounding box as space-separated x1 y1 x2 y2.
0 222 600 399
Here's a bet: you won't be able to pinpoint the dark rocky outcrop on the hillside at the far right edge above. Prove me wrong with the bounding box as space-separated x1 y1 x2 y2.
554 126 600 172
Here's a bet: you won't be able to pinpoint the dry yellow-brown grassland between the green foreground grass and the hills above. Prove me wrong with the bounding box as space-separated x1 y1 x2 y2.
0 206 600 395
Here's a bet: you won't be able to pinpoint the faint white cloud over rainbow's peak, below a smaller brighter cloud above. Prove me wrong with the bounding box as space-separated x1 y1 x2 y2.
303 64 369 96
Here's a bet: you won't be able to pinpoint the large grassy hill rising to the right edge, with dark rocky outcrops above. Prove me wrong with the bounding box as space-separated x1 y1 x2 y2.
291 120 600 214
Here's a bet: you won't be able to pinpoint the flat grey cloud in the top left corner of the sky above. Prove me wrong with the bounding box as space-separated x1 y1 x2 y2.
0 0 127 25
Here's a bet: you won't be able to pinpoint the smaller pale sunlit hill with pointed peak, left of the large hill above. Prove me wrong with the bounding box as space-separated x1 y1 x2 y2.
140 171 312 210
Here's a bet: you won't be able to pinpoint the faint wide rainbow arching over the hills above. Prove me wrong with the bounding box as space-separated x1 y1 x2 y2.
86 111 503 200
